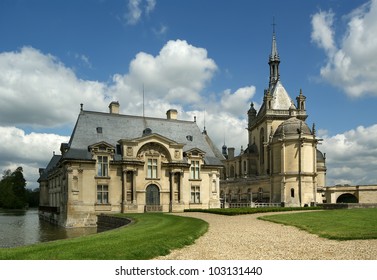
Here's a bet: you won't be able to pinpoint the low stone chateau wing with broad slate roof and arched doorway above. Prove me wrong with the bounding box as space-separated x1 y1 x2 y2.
39 102 224 227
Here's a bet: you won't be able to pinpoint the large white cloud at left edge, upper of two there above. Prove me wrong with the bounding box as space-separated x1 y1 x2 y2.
0 47 107 127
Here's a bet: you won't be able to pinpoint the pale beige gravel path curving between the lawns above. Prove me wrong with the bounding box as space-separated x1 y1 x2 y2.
153 213 377 260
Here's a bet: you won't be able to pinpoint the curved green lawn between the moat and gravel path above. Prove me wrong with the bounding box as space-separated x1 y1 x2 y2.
0 213 208 260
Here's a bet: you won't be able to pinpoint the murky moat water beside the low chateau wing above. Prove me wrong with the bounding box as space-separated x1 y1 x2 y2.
0 209 97 248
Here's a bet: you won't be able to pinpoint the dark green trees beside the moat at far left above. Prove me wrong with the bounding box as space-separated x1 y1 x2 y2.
0 167 27 209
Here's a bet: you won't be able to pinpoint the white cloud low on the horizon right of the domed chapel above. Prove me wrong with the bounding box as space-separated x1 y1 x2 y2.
319 124 377 185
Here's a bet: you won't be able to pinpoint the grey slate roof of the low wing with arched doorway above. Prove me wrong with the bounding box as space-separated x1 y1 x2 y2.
63 110 224 165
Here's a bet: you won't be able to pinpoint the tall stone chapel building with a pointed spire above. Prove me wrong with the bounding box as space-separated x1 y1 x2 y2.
221 32 326 206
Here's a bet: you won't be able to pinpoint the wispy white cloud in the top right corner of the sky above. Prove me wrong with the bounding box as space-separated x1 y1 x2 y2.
311 0 377 97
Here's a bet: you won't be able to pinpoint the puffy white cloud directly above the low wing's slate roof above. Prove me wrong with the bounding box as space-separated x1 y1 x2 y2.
111 40 217 110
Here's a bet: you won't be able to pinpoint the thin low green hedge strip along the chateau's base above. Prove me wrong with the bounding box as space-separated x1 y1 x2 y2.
185 207 323 216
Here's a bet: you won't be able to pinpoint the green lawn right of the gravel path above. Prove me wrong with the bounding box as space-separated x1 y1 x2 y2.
259 208 377 240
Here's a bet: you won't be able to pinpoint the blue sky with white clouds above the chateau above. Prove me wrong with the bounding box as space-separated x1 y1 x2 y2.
0 0 377 188
